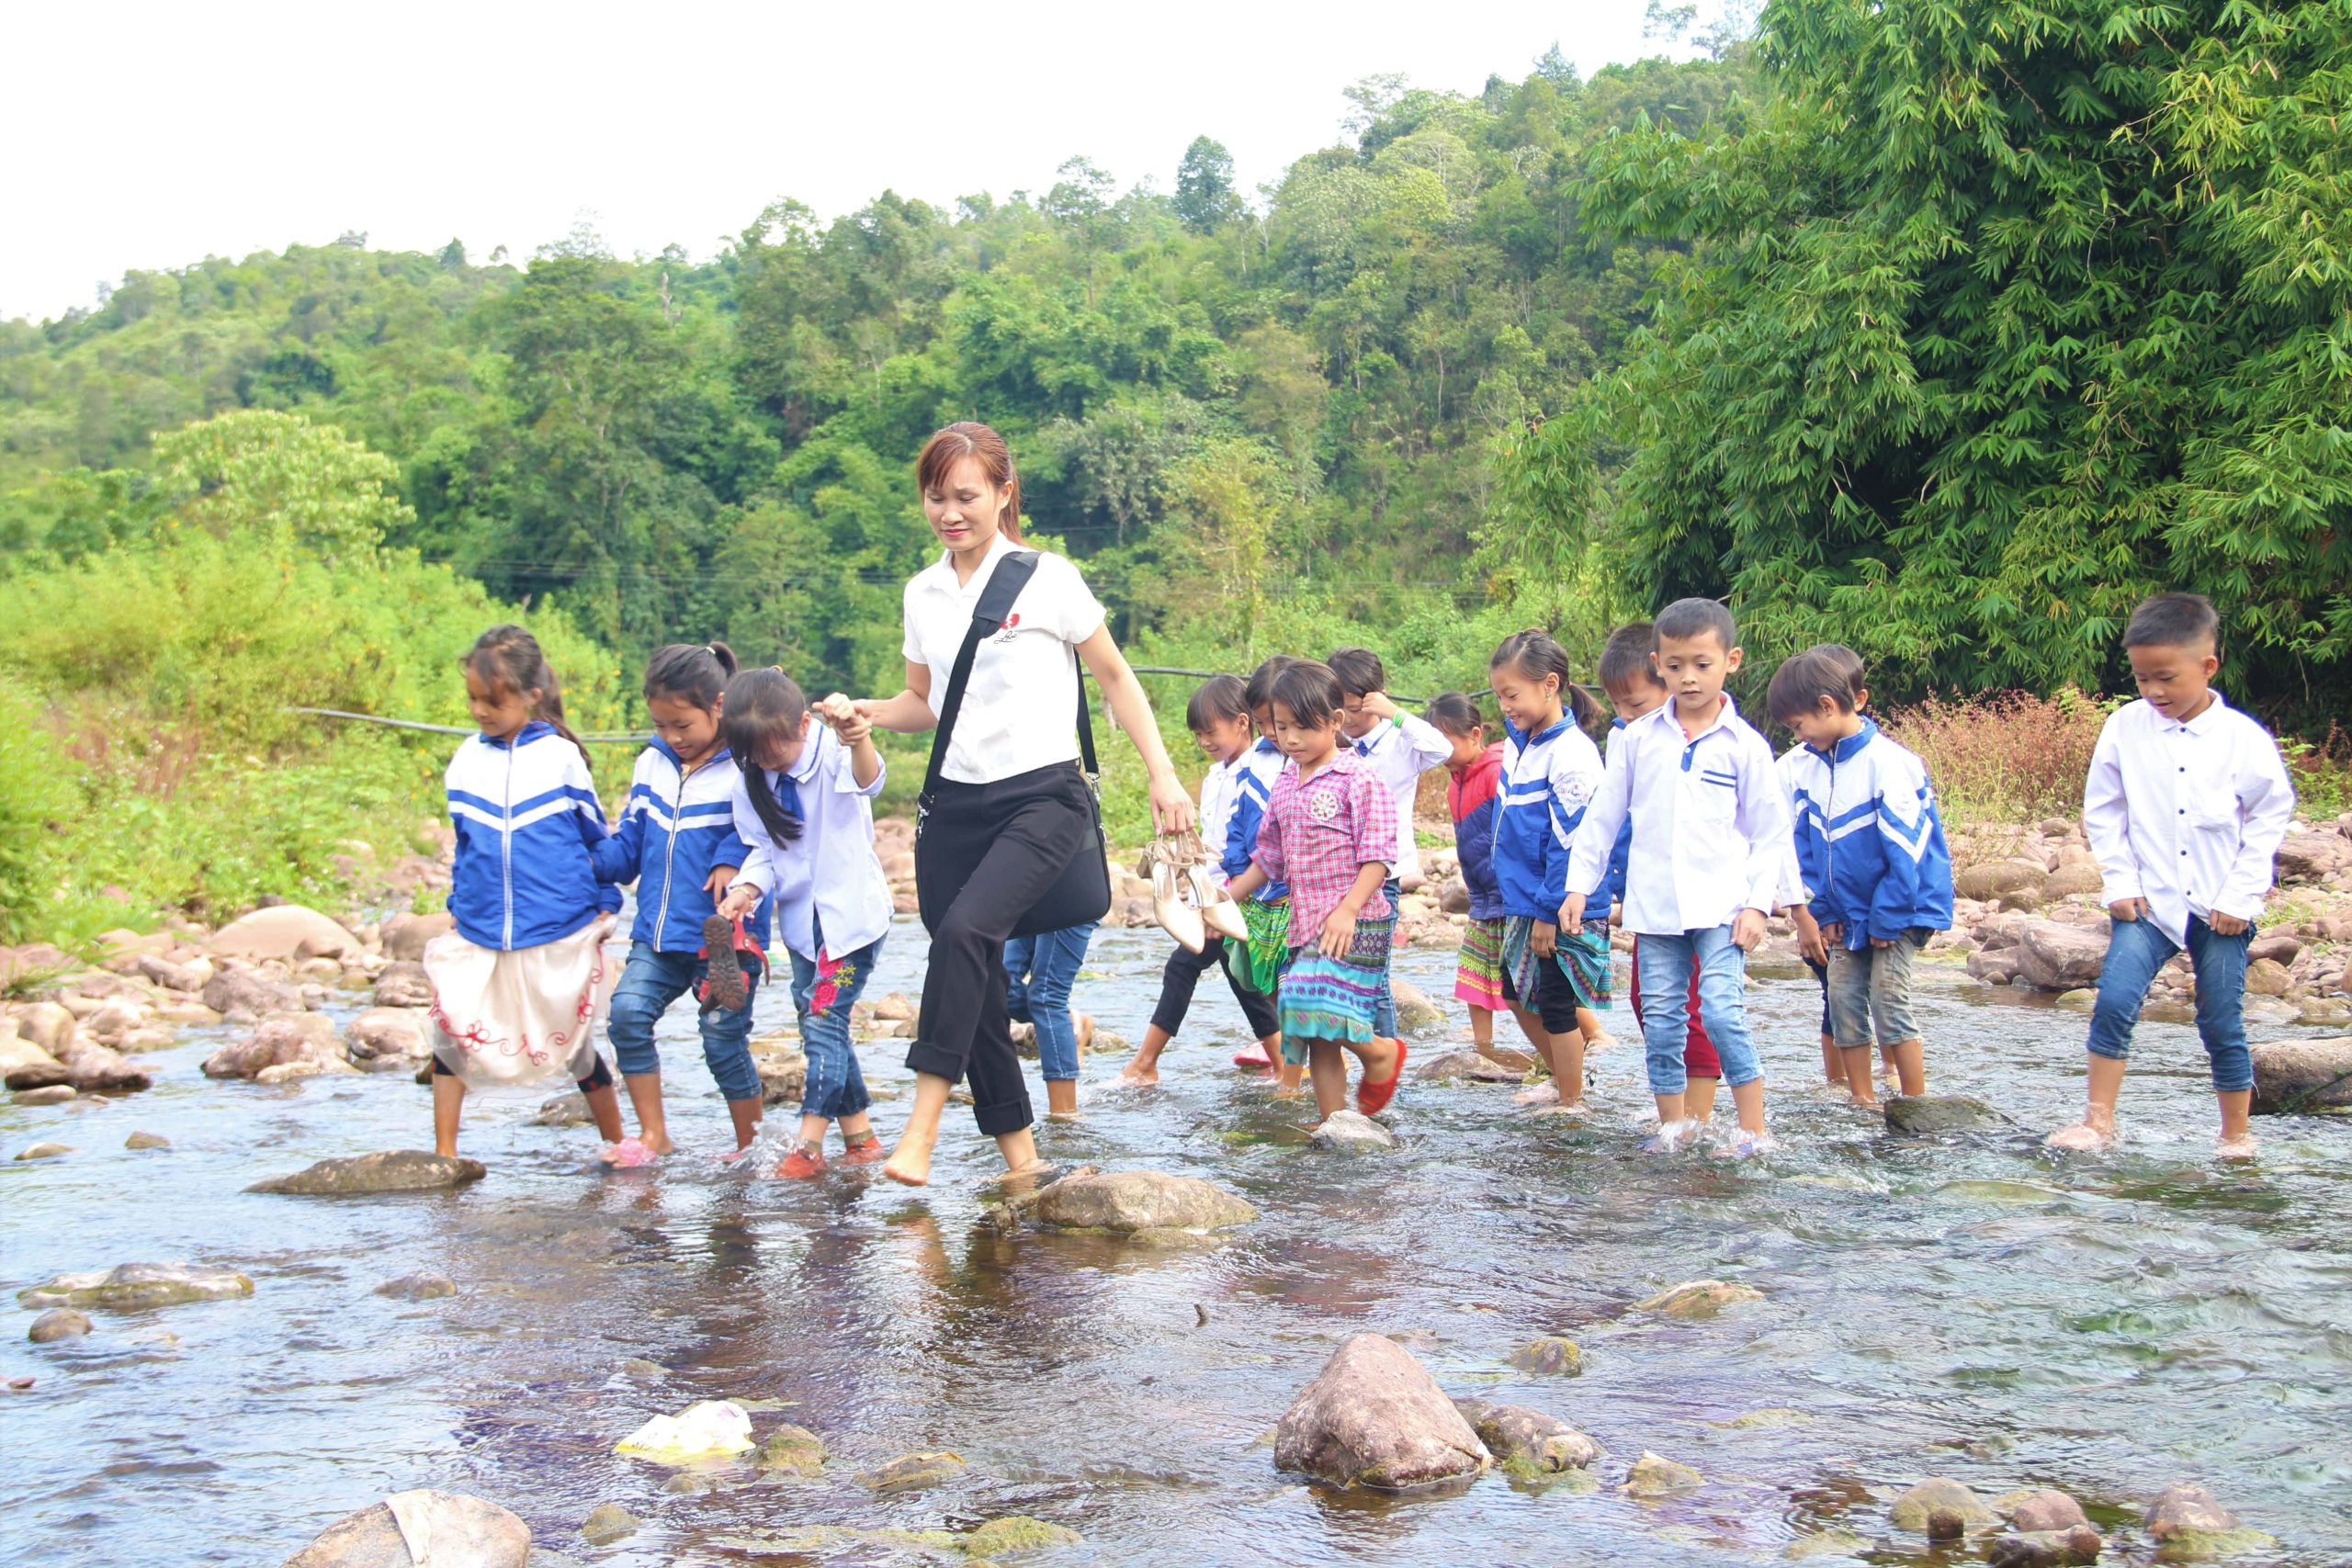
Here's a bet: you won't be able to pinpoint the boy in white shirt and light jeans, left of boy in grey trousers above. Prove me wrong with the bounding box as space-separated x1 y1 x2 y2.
1559 600 1792 1156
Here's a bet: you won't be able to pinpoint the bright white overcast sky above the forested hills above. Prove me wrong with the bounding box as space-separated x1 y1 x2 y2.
0 0 1658 320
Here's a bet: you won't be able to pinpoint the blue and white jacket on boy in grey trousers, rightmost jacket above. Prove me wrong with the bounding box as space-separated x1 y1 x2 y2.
1778 719 1952 952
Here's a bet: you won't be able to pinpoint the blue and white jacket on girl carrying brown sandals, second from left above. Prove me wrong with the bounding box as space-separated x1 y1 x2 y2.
595 736 767 952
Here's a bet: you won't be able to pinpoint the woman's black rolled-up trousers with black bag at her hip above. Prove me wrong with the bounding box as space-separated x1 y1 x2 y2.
906 761 1093 1138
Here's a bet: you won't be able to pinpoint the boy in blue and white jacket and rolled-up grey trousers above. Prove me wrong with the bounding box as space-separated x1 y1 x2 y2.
1764 642 1952 1107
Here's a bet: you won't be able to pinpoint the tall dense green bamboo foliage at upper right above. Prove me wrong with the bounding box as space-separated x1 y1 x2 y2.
1512 0 2352 715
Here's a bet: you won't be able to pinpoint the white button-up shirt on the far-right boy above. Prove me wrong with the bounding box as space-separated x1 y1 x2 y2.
2082 691 2296 947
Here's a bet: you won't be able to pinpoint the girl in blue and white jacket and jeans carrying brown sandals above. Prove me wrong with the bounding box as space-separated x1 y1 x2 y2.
595 642 767 1166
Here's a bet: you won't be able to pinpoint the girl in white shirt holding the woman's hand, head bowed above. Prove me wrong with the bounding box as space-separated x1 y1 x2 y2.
719 670 891 1180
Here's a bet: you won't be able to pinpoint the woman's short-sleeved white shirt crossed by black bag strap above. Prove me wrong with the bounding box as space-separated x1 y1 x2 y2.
906 534 1103 783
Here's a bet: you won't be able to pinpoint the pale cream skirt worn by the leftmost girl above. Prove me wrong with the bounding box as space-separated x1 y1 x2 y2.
425 915 614 1086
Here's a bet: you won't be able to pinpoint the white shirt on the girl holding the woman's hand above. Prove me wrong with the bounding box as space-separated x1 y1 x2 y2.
734 724 891 962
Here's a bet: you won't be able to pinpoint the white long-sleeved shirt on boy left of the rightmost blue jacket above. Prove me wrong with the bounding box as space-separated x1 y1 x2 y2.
1569 696 1797 936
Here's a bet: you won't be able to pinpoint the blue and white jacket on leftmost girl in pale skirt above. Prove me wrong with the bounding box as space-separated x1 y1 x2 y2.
442 719 621 952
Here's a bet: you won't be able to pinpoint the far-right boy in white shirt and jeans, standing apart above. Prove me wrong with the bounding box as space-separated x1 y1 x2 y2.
2049 592 2296 1159
